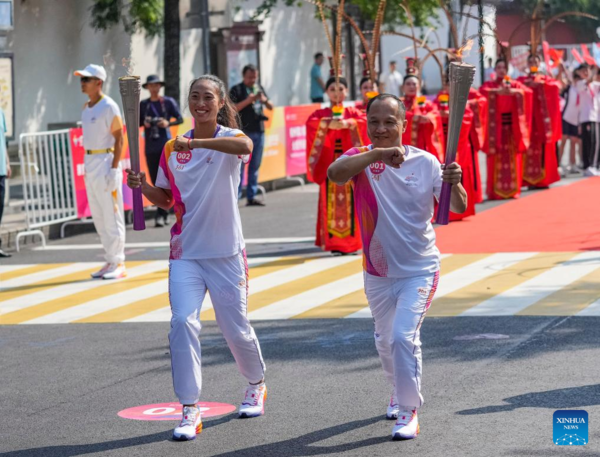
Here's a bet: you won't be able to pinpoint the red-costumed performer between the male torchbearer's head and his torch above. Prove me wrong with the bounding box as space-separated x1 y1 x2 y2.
402 57 444 162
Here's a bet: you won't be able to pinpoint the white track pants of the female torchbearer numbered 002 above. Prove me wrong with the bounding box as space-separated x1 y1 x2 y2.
169 252 265 405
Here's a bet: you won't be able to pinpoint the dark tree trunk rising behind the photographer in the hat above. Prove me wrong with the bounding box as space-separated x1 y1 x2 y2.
164 0 181 106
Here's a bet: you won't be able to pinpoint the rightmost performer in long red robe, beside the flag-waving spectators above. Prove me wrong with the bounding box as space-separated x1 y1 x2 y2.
518 54 562 188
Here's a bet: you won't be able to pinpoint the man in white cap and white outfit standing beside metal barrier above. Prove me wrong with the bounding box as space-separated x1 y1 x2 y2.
75 65 126 279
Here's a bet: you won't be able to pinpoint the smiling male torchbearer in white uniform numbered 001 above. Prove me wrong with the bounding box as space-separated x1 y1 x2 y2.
328 94 467 439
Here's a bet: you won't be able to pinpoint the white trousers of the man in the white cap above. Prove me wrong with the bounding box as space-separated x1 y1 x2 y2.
85 153 125 263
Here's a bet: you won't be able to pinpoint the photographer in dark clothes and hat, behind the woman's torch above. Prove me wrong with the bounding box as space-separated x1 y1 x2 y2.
140 75 183 227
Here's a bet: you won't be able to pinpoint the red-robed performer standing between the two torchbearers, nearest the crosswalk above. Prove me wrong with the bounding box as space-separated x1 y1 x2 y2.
306 76 368 255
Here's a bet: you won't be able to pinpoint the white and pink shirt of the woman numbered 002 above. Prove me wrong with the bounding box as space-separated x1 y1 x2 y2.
156 125 249 259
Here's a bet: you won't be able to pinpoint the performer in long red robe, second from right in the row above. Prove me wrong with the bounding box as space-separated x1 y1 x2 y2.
480 58 532 200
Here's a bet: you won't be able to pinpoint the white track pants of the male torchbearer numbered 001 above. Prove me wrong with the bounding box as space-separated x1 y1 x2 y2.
365 273 439 409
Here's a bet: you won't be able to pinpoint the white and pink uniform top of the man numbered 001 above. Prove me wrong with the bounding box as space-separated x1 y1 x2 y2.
338 145 442 278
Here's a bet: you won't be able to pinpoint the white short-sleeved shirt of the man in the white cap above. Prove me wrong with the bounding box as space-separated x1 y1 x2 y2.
81 95 123 150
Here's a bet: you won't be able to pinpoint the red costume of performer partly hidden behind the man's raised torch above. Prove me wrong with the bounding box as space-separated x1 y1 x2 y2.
434 90 481 221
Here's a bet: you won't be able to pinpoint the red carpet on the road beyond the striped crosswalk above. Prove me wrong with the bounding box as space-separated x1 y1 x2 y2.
436 178 600 254
